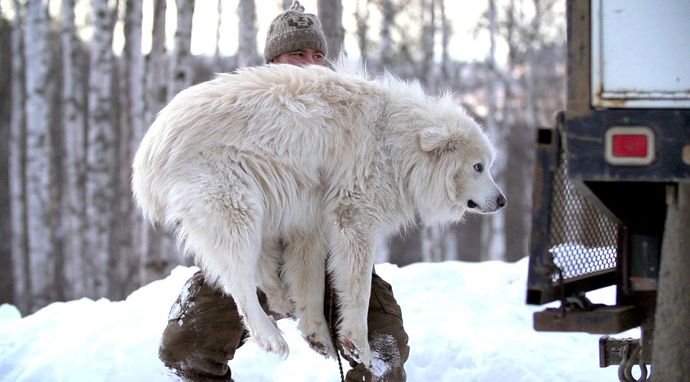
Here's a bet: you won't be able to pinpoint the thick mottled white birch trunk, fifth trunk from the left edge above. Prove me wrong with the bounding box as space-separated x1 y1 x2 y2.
86 0 118 297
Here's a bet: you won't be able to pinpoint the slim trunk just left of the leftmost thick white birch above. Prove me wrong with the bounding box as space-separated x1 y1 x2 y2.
9 0 32 312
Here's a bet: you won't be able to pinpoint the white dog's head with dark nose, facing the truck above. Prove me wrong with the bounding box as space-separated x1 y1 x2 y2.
419 101 507 222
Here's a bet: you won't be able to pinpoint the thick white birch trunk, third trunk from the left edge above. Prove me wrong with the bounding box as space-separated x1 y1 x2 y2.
24 0 59 307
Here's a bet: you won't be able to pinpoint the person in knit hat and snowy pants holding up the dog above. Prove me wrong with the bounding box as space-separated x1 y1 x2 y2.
159 1 409 382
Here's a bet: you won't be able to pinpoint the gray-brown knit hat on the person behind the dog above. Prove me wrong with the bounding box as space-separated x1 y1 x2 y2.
264 0 328 63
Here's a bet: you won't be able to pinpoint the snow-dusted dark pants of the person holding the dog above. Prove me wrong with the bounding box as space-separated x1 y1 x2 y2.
159 272 410 382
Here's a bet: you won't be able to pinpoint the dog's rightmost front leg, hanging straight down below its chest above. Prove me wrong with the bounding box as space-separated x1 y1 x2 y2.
328 219 375 367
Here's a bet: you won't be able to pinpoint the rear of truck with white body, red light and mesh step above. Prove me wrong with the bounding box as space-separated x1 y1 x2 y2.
526 0 690 382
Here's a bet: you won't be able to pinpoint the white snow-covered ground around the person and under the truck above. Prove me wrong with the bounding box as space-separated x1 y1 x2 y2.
0 259 637 382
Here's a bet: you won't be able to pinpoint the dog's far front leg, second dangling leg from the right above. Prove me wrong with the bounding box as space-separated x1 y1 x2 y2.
283 231 335 358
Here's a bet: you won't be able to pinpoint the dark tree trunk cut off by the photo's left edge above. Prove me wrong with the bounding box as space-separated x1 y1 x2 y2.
0 4 14 303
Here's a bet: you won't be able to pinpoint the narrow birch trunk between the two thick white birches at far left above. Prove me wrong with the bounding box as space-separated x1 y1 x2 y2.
62 0 87 297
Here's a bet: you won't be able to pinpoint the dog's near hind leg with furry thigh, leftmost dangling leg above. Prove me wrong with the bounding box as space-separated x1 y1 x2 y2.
180 174 289 358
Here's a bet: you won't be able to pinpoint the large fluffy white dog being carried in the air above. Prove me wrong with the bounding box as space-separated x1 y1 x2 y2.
132 65 506 365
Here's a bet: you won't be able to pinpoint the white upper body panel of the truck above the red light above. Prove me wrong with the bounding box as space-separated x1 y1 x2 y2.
591 0 690 108
